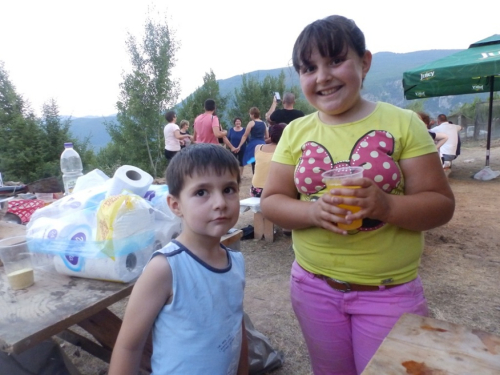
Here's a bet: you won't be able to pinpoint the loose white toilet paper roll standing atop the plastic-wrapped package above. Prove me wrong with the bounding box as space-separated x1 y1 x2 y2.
106 165 153 197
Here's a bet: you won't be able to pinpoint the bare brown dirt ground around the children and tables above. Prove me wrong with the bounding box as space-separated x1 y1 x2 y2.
64 140 500 375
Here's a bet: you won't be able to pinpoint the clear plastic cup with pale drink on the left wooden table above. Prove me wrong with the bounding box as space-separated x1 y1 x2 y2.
0 236 35 290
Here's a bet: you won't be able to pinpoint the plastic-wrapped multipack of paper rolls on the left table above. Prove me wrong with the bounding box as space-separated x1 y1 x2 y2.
27 170 181 282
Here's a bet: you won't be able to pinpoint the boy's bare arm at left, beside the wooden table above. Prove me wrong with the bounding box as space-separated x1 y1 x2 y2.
108 255 172 375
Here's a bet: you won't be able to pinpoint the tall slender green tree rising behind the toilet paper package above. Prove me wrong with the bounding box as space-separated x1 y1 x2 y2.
103 9 179 177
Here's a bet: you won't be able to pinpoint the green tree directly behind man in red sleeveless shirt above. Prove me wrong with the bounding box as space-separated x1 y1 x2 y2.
177 70 228 127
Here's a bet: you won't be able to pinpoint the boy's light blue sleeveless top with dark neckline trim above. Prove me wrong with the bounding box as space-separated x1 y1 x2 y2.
146 240 245 375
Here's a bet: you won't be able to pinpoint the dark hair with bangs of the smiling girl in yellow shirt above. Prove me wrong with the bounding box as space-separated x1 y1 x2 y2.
292 15 366 72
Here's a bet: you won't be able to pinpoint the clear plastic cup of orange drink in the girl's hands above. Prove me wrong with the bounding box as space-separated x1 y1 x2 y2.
321 167 364 230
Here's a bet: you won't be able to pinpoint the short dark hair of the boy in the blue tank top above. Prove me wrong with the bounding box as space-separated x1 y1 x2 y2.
165 143 241 198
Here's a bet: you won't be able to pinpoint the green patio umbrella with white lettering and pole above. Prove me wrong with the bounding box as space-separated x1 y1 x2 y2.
403 34 500 167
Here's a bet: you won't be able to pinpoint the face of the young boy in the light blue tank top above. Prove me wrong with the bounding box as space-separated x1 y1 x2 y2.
168 171 240 237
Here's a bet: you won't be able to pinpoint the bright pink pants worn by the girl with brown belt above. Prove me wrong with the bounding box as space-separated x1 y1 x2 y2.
290 262 428 375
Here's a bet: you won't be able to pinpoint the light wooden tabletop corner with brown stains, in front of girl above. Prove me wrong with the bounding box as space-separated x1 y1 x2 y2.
362 314 500 375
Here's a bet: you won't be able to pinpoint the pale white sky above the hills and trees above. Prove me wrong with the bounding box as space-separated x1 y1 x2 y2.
0 0 500 117
